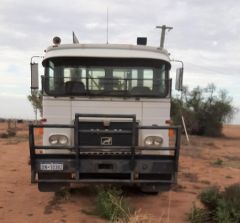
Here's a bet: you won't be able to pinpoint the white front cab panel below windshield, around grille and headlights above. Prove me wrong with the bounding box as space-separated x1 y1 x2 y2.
43 97 170 153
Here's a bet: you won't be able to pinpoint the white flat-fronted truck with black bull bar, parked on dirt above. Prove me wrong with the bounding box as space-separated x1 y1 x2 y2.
29 31 180 192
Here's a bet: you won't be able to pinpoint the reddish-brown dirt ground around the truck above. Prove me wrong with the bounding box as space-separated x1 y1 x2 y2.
0 123 240 223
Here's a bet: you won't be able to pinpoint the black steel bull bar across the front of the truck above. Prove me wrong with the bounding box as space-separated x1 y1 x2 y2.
29 114 181 186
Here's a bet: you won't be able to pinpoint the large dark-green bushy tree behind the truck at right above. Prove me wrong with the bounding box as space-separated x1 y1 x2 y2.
171 84 236 136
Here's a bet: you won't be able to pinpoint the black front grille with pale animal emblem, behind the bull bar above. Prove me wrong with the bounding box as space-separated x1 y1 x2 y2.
78 121 137 147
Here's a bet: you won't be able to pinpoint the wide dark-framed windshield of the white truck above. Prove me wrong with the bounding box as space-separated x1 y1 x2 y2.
44 58 169 97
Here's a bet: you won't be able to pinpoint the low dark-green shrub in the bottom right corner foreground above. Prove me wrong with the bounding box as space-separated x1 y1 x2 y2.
188 184 240 223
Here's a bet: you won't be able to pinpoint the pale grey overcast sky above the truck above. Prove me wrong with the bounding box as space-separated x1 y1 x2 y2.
0 0 240 124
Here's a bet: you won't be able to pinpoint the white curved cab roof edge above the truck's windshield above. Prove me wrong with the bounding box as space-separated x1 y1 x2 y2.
43 44 170 63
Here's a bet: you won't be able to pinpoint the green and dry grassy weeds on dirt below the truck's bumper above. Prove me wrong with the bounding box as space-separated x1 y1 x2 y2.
54 185 166 223
